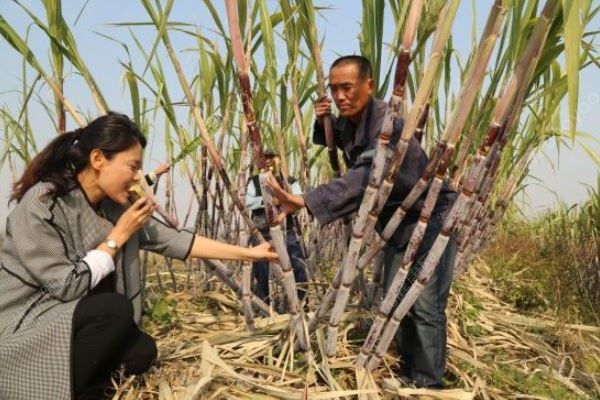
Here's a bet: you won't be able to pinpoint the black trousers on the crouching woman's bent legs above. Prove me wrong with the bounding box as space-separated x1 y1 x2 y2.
71 292 157 399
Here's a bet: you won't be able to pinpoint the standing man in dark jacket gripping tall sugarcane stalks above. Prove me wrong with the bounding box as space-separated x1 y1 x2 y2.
269 56 456 388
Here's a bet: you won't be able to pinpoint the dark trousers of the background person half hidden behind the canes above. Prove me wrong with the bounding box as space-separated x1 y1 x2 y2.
252 232 308 304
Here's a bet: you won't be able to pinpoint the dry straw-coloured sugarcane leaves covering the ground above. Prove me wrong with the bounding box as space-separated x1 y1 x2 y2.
117 261 600 400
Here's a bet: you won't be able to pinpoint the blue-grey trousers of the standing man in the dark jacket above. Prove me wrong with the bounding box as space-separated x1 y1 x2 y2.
384 224 457 387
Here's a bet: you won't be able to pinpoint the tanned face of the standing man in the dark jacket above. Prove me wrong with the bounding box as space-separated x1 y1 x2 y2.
329 64 373 122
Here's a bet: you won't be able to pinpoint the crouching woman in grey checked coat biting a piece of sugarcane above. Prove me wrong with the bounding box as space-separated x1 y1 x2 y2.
0 113 277 400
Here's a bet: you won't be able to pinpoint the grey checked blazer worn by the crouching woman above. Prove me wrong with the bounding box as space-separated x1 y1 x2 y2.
0 183 193 400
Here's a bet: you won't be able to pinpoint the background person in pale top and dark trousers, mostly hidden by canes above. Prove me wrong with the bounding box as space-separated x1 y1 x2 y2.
246 149 307 304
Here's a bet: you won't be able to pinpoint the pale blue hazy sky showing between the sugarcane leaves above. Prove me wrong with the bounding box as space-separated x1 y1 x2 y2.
0 0 600 227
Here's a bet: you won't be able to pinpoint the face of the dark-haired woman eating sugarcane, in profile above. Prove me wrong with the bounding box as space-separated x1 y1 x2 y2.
97 143 142 205
